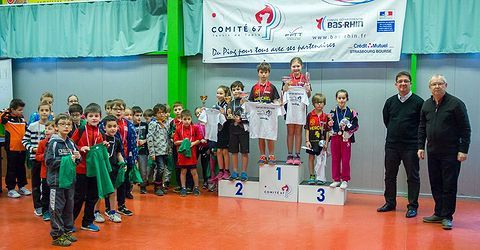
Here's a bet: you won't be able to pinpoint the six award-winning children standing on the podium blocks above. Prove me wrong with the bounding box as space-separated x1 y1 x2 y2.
200 57 358 189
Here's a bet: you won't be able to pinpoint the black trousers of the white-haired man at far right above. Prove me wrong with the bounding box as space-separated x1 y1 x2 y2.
428 153 461 220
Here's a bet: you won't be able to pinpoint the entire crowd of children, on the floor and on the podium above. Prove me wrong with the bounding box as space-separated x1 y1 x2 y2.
1 57 358 246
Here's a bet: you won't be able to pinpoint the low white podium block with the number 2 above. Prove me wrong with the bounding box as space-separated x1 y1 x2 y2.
218 178 258 199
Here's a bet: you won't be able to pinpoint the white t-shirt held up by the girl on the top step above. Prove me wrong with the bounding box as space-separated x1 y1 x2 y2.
283 87 310 125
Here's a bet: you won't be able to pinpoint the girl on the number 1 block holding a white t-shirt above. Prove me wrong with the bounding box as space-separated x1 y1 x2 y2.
282 57 312 165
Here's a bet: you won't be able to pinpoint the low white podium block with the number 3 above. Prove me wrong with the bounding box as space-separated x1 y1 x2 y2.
298 181 347 205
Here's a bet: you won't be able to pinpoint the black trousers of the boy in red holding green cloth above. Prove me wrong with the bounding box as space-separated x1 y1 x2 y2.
73 174 98 226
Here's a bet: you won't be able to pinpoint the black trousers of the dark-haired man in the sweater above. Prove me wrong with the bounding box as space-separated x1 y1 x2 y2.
384 148 420 210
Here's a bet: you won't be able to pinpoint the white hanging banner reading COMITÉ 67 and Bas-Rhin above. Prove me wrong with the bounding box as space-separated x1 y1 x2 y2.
203 0 407 63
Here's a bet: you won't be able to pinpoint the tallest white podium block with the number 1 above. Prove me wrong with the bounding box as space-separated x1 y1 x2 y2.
259 163 303 202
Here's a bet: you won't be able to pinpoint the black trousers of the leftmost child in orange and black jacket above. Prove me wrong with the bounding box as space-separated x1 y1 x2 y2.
5 150 27 190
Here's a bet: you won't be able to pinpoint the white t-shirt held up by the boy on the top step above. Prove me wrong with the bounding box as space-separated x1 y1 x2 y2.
244 102 285 141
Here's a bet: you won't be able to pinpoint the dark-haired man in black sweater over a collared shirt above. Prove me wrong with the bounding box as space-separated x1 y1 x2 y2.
377 71 423 218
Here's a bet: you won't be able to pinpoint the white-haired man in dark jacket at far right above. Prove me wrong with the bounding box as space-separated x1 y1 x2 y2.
418 75 471 230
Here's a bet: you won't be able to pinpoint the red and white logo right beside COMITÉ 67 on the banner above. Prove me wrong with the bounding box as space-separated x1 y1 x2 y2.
255 4 283 40
